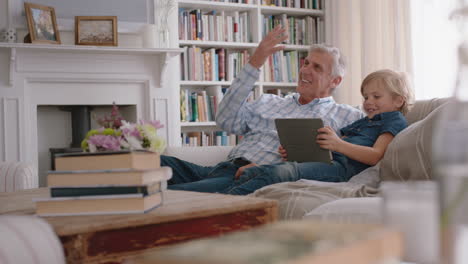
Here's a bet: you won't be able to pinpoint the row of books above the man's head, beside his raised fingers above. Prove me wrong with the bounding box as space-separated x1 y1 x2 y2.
262 14 324 45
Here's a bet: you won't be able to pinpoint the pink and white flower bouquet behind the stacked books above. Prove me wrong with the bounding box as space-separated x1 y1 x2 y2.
81 104 166 153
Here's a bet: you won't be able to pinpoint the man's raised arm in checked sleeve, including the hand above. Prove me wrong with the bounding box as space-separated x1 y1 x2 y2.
216 27 288 134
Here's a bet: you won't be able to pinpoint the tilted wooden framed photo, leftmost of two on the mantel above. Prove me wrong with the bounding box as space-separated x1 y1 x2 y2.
24 2 60 44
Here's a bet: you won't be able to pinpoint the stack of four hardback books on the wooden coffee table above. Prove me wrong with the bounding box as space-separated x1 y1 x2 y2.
35 151 172 216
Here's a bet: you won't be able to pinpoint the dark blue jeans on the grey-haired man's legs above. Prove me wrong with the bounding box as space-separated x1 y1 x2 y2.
161 155 240 193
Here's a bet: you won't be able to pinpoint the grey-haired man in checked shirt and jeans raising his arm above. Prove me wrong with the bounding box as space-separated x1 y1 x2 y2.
161 27 362 192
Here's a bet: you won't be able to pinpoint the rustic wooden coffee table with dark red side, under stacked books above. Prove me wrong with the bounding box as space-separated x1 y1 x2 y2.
0 188 278 263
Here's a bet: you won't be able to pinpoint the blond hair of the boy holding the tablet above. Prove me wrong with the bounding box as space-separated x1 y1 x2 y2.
361 69 413 114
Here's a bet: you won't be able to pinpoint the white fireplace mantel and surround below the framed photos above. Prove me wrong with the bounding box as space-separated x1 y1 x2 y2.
0 43 182 177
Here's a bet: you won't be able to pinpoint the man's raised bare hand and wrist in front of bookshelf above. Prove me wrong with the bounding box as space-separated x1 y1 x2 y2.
249 25 288 69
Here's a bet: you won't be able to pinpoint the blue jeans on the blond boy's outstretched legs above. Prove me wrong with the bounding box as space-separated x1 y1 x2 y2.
222 161 357 195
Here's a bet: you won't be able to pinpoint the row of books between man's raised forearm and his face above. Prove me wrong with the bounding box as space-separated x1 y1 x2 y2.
263 50 307 82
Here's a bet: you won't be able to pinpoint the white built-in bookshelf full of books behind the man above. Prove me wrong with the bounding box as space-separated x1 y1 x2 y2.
178 0 325 146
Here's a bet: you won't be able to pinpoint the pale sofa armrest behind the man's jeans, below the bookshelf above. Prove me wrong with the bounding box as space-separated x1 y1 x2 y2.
163 146 232 166
